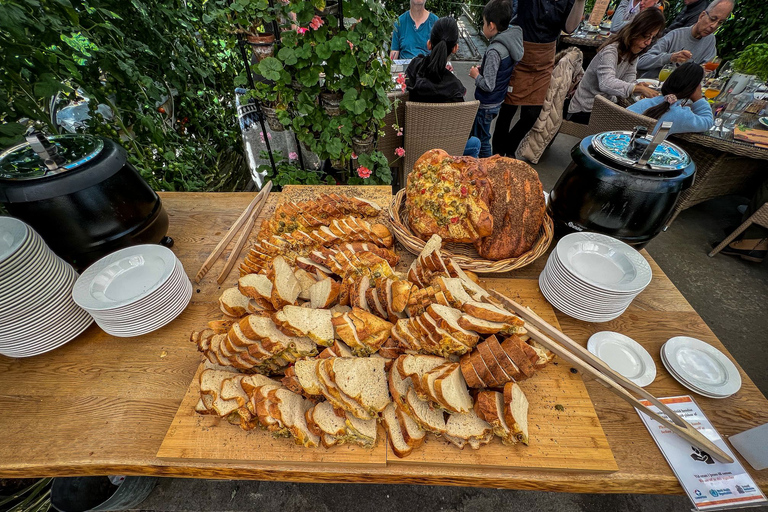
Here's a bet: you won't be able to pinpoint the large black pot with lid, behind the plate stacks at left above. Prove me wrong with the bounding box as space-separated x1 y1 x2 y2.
0 135 172 270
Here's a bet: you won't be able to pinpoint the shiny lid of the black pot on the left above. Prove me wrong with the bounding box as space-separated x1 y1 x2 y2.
0 134 104 180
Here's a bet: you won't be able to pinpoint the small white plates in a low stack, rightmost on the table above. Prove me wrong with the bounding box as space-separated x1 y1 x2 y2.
661 336 741 398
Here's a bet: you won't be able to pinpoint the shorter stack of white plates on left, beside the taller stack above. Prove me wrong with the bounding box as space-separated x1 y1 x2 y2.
72 245 192 337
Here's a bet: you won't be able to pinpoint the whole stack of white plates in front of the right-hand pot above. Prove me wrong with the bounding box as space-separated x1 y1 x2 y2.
539 233 652 322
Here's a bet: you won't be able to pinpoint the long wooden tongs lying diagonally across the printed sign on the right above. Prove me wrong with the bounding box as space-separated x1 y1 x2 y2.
489 290 733 463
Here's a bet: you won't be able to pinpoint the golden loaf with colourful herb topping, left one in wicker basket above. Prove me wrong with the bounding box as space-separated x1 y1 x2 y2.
405 149 494 243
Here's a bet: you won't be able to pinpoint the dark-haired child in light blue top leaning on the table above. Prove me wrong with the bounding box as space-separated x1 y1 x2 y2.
627 62 715 134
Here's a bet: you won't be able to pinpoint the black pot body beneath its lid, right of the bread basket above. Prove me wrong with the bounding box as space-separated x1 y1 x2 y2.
549 134 696 247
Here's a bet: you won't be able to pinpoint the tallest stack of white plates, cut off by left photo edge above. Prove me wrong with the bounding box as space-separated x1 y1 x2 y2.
0 217 93 357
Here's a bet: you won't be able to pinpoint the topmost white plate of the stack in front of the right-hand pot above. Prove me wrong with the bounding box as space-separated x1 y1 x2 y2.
555 232 652 293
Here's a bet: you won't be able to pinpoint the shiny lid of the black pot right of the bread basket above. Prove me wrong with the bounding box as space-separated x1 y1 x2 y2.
592 130 691 172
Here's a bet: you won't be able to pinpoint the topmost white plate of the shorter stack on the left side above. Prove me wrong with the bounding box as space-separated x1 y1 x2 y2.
72 245 177 311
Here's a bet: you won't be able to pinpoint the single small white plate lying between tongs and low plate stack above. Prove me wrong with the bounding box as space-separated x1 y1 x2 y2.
587 331 656 387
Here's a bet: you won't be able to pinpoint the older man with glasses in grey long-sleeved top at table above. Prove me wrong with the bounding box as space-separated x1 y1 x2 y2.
637 0 733 78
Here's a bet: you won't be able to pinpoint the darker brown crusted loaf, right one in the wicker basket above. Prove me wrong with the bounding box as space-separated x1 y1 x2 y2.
474 155 546 260
